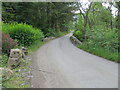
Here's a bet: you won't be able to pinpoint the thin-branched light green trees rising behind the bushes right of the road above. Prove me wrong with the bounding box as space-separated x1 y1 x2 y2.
75 2 119 41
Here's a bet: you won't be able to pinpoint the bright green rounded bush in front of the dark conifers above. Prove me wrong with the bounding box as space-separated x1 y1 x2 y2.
3 23 44 46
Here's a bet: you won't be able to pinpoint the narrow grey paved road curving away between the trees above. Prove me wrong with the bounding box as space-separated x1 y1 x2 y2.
33 34 118 88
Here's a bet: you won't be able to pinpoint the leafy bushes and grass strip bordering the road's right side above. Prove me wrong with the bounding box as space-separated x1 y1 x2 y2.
74 25 120 62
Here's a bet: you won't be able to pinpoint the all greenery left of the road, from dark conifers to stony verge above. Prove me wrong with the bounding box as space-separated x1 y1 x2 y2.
0 2 76 88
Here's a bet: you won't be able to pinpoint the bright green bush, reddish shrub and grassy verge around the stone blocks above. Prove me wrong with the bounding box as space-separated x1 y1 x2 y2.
0 23 44 88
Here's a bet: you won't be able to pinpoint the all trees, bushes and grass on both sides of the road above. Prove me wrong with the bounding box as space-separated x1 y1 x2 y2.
0 2 120 88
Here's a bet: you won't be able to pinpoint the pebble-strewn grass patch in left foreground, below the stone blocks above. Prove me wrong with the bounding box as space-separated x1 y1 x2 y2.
2 59 32 88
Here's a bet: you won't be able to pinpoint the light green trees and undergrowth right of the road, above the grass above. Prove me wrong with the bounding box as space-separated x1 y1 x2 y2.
74 2 120 52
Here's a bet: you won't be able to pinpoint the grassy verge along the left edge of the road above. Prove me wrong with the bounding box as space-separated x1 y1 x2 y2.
2 41 44 88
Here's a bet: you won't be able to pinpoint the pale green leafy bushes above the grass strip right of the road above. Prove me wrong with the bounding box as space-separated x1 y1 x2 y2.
88 25 118 51
